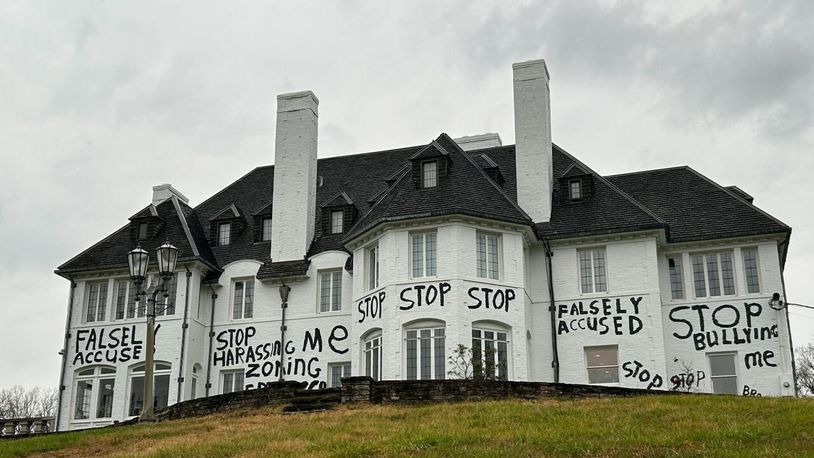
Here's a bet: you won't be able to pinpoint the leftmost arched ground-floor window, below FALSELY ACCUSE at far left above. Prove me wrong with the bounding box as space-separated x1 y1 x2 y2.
73 366 116 420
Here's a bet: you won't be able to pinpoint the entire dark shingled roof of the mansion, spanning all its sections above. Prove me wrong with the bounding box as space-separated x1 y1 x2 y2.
57 134 790 282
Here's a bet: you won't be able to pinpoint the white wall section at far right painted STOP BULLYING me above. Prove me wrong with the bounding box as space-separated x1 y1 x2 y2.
659 241 794 396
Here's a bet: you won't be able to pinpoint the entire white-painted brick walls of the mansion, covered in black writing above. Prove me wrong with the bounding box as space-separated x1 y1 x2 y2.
60 231 794 429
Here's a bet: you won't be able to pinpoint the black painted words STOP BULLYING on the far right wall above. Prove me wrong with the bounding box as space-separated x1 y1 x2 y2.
669 302 778 351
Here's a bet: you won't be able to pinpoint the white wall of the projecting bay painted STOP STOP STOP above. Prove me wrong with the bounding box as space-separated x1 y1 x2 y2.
351 222 529 380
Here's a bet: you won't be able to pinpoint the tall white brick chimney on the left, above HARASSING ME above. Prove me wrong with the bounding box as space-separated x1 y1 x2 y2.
271 91 319 262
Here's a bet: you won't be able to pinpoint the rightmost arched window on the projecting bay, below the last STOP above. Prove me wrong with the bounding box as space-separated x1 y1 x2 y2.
472 321 512 380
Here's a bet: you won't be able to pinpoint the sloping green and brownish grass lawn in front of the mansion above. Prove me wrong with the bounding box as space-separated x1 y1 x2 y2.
0 396 814 457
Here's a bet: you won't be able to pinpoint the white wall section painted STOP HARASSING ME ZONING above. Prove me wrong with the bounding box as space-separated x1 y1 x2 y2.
210 252 351 394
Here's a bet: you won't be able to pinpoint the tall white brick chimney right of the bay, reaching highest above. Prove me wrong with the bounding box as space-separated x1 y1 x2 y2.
512 59 553 223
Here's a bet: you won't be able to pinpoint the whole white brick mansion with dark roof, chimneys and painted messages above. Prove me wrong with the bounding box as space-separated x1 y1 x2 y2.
57 61 794 430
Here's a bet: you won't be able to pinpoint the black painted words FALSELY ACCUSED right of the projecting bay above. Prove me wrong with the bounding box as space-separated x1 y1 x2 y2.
557 297 644 336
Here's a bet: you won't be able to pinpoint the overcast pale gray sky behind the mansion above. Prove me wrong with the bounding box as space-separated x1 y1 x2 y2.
0 0 814 387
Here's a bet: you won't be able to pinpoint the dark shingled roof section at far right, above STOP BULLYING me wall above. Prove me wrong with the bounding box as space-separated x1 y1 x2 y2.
608 166 791 242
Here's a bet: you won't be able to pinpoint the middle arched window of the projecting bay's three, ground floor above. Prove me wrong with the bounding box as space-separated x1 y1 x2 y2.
404 320 446 380
